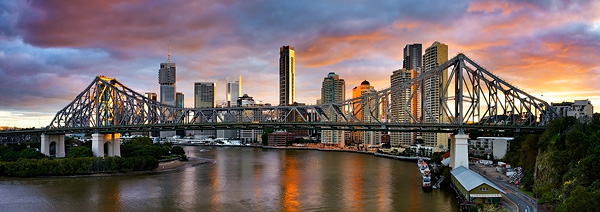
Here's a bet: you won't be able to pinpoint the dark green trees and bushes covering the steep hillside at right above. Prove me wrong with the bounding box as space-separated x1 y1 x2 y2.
505 114 600 211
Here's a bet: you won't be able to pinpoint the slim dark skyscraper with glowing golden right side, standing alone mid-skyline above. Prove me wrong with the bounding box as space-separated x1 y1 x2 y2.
279 46 296 106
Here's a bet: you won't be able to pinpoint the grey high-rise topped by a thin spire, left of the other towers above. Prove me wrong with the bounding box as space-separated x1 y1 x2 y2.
158 62 177 106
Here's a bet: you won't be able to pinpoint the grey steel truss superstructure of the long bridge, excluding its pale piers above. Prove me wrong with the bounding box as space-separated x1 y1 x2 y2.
0 54 558 139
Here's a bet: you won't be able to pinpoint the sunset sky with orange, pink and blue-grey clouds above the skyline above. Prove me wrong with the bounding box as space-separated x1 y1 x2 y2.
0 0 600 127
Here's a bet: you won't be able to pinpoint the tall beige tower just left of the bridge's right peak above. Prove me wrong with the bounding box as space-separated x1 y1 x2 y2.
423 41 448 149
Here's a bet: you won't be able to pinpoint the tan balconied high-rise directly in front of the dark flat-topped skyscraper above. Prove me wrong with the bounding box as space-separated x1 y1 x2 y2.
390 68 417 147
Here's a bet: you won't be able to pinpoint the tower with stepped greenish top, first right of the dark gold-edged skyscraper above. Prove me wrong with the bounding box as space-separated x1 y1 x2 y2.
321 72 346 146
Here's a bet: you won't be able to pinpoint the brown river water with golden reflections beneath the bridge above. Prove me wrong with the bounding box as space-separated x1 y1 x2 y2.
0 147 458 211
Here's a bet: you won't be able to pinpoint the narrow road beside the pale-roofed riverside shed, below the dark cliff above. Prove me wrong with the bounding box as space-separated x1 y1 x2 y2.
469 164 538 212
